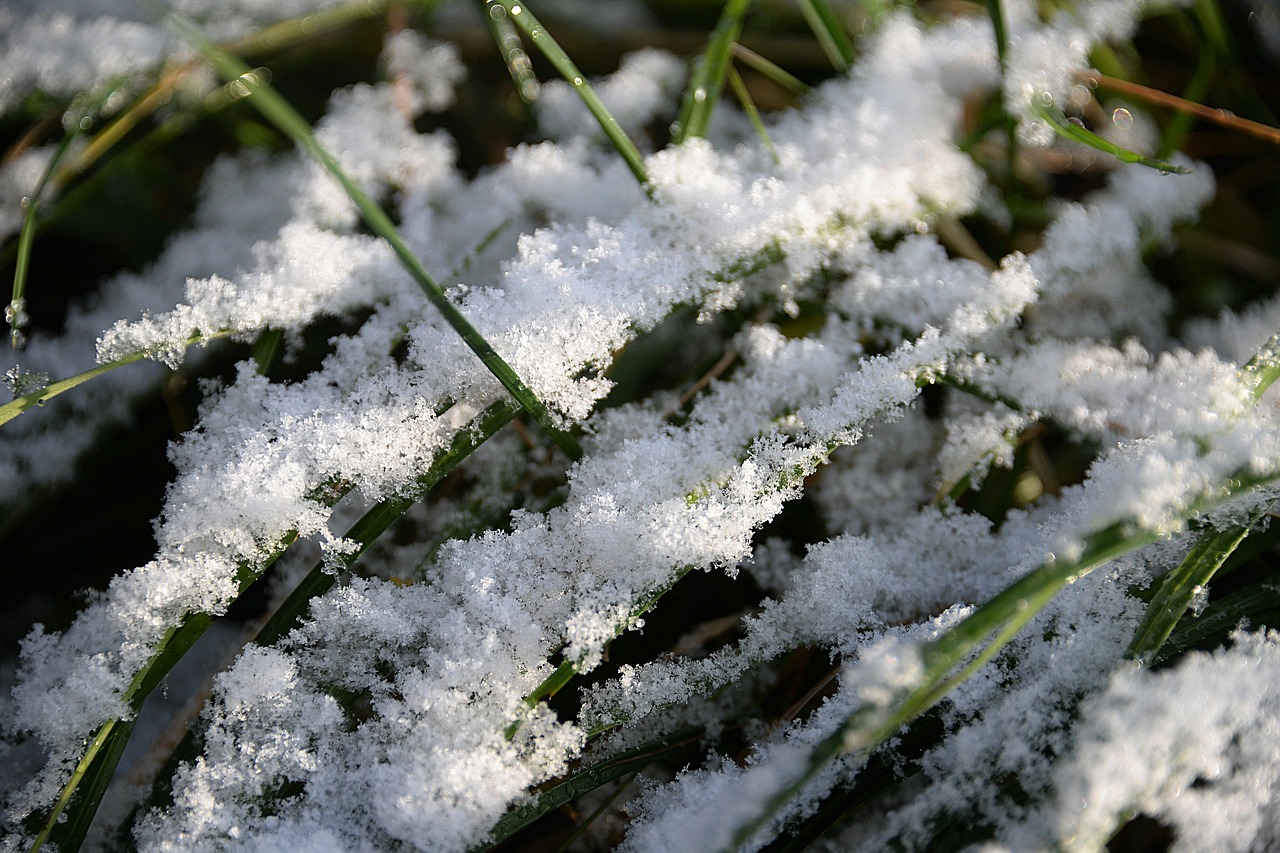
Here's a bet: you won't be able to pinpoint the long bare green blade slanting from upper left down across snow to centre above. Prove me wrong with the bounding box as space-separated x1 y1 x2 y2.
169 15 582 460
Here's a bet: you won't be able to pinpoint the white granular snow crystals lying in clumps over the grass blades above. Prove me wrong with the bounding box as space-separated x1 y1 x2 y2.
0 0 1280 850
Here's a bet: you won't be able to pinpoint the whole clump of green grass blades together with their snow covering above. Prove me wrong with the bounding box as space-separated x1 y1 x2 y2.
0 0 1280 852
